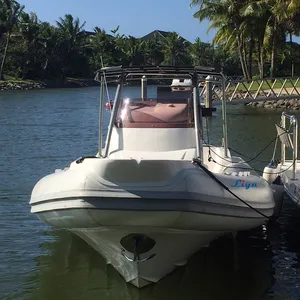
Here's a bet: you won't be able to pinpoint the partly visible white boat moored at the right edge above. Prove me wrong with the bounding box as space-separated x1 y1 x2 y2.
263 111 300 211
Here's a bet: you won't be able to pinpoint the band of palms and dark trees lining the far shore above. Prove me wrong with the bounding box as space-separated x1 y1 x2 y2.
0 0 300 95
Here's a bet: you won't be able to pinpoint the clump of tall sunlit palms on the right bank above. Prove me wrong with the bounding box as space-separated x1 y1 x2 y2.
191 0 300 78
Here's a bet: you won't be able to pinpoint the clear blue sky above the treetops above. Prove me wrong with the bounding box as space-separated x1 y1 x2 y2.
19 0 214 42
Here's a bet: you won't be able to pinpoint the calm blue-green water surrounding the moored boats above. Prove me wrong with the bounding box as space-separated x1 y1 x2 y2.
0 88 300 300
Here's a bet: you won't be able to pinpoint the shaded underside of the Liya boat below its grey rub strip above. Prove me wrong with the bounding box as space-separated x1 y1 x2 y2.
34 209 270 287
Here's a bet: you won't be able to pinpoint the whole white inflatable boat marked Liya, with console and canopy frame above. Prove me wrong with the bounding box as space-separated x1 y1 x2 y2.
30 66 282 288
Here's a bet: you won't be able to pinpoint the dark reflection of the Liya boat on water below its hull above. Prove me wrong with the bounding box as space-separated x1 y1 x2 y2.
28 227 274 300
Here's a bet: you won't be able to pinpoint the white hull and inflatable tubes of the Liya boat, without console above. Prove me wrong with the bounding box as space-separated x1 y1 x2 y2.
30 158 274 287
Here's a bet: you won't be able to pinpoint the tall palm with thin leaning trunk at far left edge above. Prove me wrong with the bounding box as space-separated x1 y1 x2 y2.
0 0 24 80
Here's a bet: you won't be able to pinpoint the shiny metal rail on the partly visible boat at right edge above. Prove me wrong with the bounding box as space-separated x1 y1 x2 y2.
281 112 298 180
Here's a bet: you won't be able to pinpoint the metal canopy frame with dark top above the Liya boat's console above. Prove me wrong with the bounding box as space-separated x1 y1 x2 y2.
95 66 228 160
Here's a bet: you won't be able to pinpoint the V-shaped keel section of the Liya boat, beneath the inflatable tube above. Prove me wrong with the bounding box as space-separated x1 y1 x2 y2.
71 227 223 287
